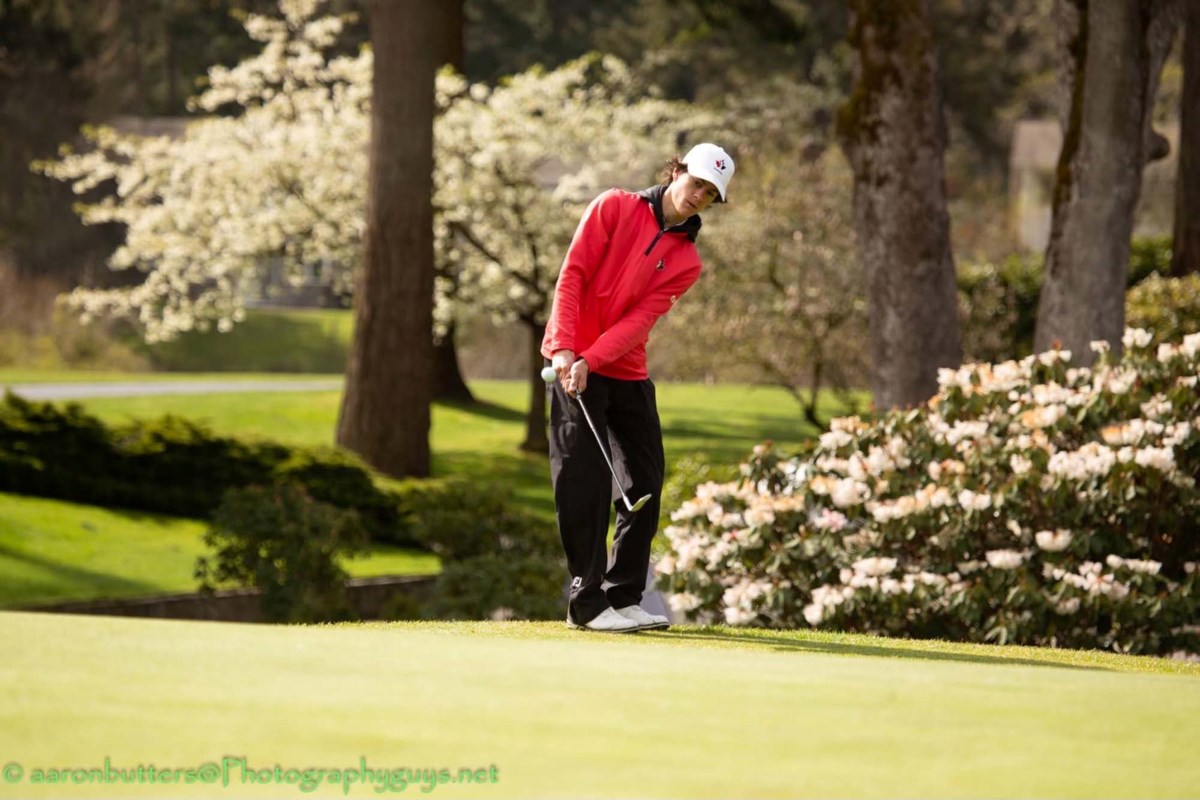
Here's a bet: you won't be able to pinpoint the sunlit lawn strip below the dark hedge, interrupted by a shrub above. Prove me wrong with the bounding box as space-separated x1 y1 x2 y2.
0 493 439 608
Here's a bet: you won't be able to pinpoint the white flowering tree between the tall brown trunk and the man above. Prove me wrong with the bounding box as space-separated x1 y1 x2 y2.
434 56 713 452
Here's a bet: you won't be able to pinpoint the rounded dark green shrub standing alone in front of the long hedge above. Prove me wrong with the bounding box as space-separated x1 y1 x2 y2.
196 482 367 622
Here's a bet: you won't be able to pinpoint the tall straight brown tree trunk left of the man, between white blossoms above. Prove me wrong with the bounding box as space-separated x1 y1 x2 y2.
337 0 445 476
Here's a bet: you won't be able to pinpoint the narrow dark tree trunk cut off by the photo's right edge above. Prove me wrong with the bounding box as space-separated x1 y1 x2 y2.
1171 0 1200 277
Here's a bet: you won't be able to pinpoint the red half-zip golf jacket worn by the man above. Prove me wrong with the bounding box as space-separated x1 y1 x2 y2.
541 186 701 380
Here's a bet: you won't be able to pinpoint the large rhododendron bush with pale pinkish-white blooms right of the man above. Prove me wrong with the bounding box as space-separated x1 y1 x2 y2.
659 330 1200 657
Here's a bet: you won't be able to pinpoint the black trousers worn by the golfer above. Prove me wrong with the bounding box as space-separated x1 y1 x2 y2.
550 373 666 625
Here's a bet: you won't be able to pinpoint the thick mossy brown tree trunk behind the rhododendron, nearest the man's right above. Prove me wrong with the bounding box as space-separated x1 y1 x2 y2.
838 0 962 409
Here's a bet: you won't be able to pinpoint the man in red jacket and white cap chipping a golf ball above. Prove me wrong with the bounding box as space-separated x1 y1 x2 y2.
541 144 733 632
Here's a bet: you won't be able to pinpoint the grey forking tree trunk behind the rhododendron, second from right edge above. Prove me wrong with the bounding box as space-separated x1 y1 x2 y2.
1033 0 1182 357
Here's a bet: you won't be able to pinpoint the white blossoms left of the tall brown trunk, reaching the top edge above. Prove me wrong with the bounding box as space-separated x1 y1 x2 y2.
41 0 372 342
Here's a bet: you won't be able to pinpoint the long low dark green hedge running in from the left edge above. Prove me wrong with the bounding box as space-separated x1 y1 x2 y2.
0 393 415 546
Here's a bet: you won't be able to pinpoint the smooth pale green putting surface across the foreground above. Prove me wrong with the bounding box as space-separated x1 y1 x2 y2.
0 613 1200 798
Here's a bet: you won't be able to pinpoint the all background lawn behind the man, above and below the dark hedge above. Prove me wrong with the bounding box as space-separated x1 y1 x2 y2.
0 373 835 607
